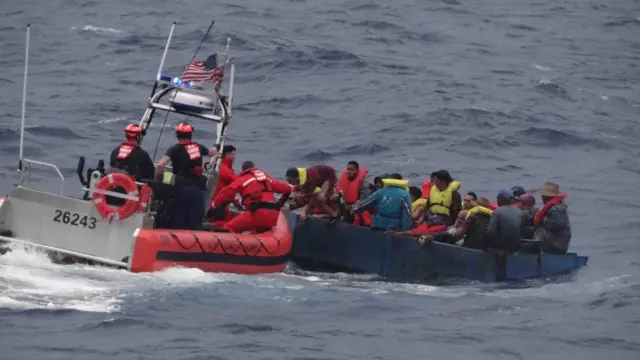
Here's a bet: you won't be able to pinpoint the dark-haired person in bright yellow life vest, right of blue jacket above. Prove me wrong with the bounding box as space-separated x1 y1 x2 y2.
427 170 462 226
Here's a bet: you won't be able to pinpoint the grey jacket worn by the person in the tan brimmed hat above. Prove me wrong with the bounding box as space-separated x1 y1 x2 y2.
533 202 571 254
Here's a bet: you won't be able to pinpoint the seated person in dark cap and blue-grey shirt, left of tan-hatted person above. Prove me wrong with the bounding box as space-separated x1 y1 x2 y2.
486 190 522 251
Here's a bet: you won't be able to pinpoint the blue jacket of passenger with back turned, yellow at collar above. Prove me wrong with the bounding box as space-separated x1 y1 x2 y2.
352 186 411 231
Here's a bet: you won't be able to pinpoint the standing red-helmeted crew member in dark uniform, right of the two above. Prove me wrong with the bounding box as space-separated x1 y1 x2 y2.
156 122 218 230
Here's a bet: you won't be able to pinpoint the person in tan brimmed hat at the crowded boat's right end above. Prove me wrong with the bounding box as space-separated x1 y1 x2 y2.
522 182 571 254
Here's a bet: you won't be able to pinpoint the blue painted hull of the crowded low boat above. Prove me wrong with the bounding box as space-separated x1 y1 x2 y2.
289 214 588 282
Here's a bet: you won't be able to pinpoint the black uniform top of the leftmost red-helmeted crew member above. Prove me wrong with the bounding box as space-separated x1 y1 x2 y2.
109 141 154 181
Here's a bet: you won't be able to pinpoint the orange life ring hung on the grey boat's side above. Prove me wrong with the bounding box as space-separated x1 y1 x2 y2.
93 173 139 221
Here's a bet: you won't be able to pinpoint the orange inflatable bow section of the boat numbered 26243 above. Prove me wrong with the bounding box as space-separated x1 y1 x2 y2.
130 212 292 274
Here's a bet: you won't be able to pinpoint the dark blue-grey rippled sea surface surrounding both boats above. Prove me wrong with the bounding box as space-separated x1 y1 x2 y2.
0 0 640 360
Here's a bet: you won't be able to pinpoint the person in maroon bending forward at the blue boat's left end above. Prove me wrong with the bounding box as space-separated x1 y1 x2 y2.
285 165 338 220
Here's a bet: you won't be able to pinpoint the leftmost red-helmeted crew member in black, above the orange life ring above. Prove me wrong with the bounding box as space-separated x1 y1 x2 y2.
108 124 153 181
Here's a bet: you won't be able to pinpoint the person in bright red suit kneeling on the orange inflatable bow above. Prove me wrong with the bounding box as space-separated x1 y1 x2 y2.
213 161 293 233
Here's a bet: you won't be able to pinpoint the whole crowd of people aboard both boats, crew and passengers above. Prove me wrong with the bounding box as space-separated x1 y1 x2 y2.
110 122 571 254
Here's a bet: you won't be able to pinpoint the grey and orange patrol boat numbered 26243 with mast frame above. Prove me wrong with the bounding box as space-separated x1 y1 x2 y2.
0 23 292 274
